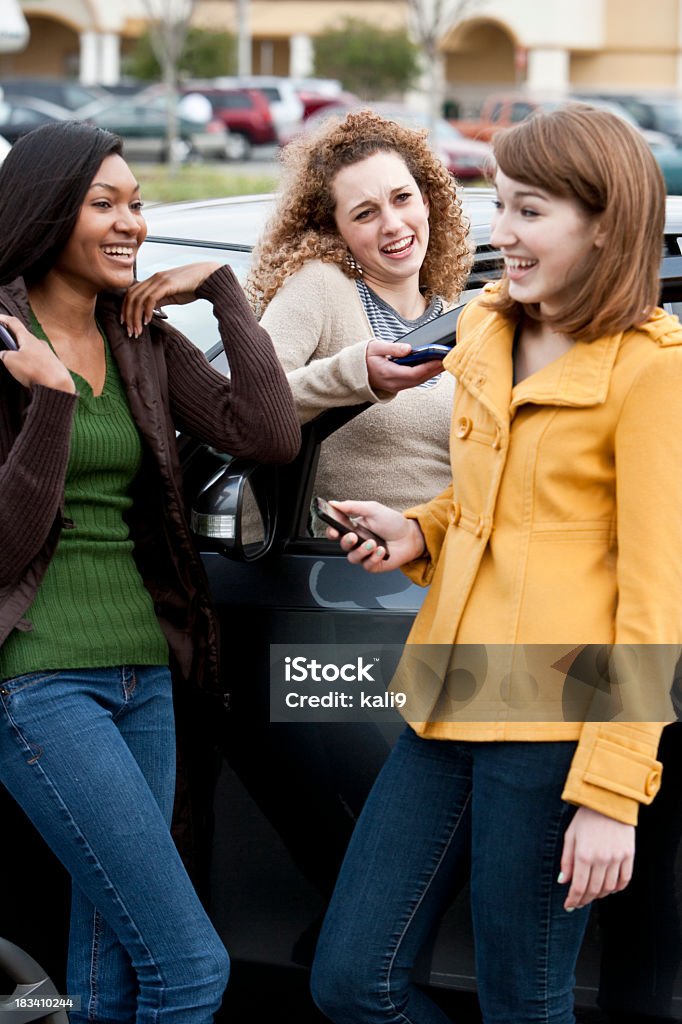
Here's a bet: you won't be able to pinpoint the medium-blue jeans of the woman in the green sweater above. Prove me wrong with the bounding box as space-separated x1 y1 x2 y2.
0 667 229 1024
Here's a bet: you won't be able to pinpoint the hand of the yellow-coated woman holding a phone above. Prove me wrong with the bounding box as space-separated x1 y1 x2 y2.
327 502 425 572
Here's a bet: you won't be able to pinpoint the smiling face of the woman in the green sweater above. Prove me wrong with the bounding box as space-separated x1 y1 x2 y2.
52 155 146 295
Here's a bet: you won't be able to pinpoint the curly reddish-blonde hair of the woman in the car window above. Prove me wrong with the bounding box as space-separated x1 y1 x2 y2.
246 111 472 316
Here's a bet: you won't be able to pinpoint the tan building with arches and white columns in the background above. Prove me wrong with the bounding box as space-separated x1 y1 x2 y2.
0 0 682 105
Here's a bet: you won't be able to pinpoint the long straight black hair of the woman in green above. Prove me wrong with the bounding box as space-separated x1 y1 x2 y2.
0 121 123 285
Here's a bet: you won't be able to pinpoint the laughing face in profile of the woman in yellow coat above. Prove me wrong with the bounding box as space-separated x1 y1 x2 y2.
491 170 603 315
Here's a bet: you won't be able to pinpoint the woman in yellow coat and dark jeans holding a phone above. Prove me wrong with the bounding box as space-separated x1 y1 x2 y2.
312 105 682 1024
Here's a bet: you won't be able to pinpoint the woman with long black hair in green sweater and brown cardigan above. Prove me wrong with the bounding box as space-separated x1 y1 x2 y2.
0 117 299 1024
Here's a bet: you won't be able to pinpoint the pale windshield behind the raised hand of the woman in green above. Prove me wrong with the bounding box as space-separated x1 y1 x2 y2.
137 238 251 356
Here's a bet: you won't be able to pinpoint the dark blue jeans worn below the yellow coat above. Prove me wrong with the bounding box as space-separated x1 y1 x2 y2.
312 728 589 1024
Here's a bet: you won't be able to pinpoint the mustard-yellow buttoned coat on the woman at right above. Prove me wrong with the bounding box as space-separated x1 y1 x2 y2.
399 286 682 823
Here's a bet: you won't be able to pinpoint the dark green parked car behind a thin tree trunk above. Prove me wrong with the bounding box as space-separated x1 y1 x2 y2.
78 87 238 160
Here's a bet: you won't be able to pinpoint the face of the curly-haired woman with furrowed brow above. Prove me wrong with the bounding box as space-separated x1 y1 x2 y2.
332 152 429 295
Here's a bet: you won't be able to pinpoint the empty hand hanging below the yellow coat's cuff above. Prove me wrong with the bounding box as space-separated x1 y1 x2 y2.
559 807 635 910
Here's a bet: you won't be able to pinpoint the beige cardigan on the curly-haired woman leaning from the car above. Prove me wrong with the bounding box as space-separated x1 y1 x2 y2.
261 260 455 511
